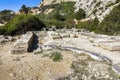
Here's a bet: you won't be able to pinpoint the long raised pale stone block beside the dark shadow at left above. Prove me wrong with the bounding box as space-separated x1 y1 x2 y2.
11 32 34 54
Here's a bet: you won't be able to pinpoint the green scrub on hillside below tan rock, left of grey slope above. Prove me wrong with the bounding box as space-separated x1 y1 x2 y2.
41 2 75 20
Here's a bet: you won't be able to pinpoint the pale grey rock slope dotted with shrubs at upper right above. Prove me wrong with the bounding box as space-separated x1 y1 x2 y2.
75 0 120 22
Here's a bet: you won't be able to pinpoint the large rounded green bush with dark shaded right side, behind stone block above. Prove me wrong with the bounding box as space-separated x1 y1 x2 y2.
5 15 45 35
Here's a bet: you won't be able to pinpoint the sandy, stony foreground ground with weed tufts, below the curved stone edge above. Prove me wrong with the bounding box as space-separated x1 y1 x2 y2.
0 43 120 80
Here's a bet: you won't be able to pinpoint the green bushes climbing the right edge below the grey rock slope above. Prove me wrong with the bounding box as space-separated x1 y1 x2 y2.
77 5 120 35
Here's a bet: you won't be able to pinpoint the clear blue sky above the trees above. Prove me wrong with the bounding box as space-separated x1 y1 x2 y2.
0 0 41 12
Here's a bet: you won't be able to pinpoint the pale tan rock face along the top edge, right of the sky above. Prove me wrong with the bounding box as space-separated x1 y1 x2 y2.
39 0 77 6
